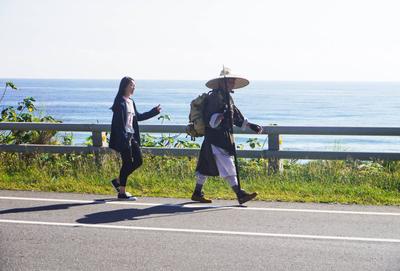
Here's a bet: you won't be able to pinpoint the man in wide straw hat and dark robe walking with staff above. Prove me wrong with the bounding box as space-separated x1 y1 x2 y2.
192 67 262 204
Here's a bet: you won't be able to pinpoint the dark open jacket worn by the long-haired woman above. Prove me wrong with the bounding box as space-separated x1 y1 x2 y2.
109 97 159 152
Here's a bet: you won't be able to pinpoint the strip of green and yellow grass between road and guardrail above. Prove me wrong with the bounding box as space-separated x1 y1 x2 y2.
0 153 400 205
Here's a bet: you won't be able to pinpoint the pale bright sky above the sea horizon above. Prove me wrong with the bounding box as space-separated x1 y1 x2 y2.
0 0 400 81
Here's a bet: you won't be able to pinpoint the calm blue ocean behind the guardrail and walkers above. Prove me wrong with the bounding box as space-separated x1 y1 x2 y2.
0 79 400 152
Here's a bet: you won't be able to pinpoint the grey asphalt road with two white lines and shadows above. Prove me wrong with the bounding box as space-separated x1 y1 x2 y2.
0 191 400 271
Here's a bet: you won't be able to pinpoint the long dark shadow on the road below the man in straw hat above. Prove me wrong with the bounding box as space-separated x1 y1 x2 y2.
76 202 222 224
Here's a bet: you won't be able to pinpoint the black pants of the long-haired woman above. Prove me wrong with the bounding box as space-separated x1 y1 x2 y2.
119 135 143 186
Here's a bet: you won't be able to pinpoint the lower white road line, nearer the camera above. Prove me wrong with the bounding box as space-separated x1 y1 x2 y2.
0 219 400 243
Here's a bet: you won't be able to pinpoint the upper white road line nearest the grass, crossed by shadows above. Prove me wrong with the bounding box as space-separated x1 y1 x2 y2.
0 197 400 216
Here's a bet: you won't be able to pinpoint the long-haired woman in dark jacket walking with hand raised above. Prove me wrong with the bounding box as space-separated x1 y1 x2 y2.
109 77 161 200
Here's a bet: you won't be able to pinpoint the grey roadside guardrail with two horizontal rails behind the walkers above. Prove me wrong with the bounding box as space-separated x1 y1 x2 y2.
0 122 400 170
